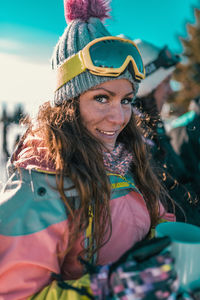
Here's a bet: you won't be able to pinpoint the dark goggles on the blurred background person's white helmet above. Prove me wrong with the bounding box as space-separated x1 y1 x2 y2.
145 46 181 77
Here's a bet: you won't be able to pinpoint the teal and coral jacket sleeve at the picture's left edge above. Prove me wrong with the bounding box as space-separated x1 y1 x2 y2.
0 170 72 300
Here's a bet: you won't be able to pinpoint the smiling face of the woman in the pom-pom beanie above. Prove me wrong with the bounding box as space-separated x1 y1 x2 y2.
79 79 134 150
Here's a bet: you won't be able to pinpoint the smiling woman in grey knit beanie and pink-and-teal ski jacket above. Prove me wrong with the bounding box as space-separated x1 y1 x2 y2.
0 0 174 300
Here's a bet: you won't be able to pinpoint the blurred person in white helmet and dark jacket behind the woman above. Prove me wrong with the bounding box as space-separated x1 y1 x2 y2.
133 40 200 226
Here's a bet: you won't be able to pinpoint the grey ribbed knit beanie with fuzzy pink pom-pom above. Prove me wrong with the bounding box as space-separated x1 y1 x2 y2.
51 0 138 106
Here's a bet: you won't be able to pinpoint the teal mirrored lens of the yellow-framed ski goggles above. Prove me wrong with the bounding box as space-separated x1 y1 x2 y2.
89 40 144 74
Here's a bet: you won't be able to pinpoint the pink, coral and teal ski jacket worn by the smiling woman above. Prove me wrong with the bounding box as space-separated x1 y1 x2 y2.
0 146 175 300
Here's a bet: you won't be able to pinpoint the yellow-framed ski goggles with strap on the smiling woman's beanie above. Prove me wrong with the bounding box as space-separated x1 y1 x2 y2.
56 36 145 90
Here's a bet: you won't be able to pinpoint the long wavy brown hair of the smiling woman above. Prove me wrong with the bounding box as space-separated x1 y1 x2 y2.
20 98 166 257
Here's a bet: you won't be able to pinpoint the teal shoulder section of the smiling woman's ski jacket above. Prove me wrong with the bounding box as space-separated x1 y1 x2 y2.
0 169 77 236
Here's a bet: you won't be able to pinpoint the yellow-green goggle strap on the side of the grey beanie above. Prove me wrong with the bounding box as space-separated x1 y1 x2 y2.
56 52 86 91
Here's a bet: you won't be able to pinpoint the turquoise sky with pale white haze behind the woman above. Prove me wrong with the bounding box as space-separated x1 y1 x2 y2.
0 0 200 112
